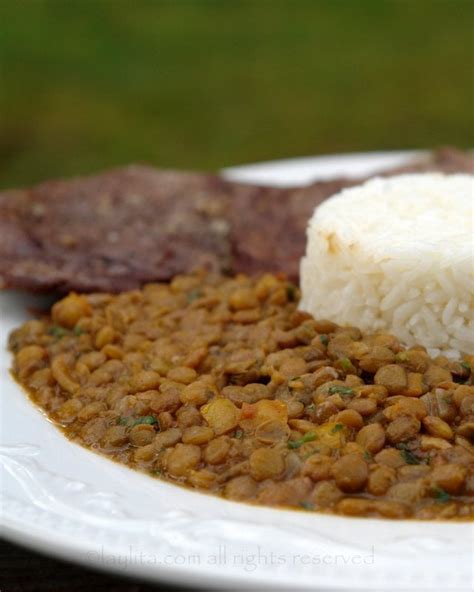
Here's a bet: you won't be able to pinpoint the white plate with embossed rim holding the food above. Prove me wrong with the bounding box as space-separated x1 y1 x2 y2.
0 153 474 590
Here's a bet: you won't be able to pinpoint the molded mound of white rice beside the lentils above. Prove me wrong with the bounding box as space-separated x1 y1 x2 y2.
300 174 474 357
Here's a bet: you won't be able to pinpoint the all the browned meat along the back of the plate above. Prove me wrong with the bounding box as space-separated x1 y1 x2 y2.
0 150 474 292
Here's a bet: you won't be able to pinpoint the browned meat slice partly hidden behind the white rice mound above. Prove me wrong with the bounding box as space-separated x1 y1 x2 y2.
230 148 474 281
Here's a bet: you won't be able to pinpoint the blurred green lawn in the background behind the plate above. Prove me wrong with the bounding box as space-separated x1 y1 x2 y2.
0 0 474 187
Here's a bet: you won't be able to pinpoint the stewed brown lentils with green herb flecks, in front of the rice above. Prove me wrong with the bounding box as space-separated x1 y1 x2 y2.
10 274 474 519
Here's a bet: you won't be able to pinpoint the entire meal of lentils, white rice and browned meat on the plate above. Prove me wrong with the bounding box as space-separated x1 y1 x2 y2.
4 150 474 520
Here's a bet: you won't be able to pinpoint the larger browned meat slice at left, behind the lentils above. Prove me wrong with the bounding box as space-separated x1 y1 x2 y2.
0 166 231 291
